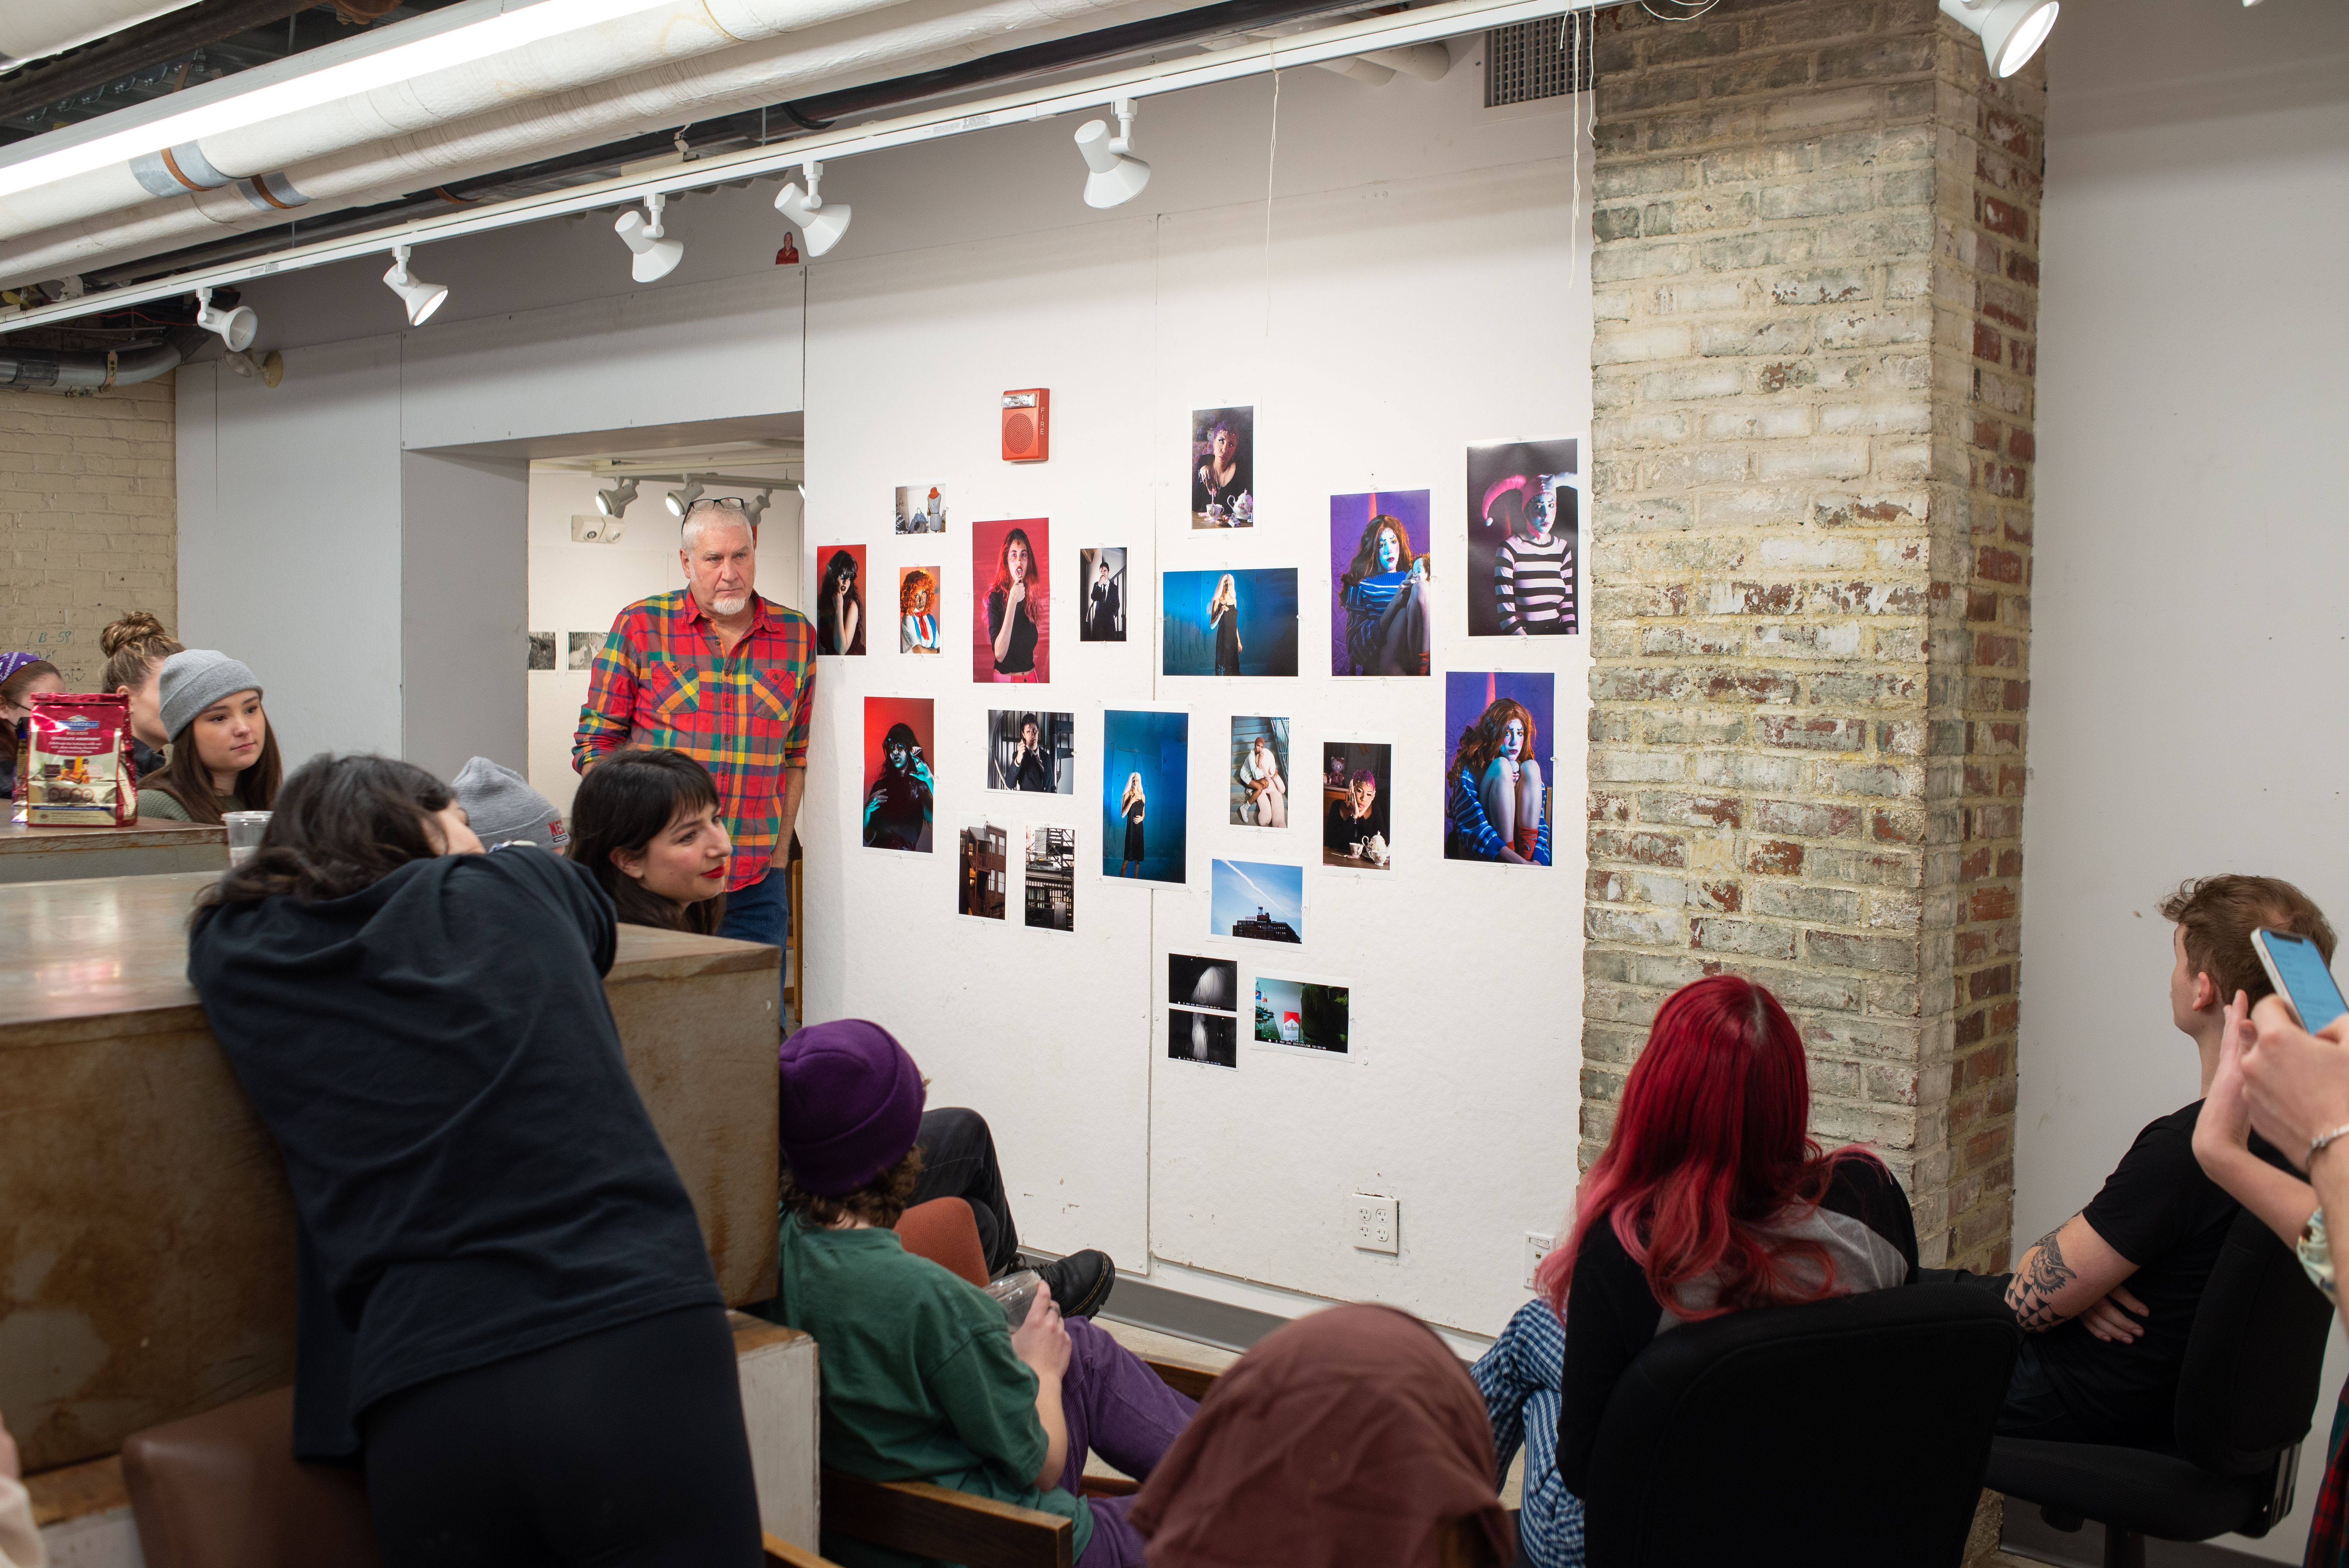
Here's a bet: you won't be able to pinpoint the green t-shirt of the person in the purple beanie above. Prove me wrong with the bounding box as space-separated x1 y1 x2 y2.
768 1213 1092 1568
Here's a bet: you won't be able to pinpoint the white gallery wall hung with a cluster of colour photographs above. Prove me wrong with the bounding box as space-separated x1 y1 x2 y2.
181 40 1590 1333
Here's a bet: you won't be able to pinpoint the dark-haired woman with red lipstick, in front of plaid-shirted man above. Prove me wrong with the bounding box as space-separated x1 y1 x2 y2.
571 747 733 937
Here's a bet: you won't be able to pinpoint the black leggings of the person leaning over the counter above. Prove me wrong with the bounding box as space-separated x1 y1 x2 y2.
359 1308 766 1568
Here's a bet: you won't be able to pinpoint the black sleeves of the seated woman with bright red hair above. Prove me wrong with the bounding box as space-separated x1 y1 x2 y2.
1558 1155 1917 1498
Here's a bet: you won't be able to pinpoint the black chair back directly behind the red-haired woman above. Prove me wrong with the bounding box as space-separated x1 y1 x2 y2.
1583 1284 2023 1568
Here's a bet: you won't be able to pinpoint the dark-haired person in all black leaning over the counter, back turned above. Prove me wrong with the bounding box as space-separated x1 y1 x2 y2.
188 756 761 1568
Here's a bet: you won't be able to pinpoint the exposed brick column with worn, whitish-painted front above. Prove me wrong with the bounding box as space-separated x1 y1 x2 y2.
1583 0 2044 1267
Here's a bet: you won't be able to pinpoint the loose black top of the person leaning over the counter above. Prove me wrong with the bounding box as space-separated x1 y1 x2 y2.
188 847 721 1458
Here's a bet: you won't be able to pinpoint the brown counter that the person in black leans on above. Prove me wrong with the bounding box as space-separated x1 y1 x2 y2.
0 878 780 1469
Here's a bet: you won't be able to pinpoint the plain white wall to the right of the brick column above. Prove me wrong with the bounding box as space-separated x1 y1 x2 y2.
2016 0 2349 1561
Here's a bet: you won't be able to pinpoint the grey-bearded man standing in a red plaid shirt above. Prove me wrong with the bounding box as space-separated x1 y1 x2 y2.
571 495 815 971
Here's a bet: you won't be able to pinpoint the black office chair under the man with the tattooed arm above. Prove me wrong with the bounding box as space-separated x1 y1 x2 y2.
1990 1211 2333 1568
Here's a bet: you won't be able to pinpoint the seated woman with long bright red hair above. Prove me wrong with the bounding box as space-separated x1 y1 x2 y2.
1475 974 1917 1568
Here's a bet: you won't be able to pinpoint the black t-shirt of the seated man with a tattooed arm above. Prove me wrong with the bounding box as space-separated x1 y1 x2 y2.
2037 1101 2283 1448
